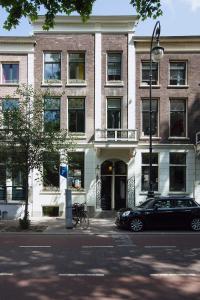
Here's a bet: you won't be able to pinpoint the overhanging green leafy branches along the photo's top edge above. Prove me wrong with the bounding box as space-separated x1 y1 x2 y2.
0 0 162 30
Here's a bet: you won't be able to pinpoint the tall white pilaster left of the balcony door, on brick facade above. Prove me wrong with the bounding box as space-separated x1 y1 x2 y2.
95 32 102 129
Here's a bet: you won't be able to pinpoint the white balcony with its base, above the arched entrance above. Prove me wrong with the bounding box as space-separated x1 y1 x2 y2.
95 129 138 148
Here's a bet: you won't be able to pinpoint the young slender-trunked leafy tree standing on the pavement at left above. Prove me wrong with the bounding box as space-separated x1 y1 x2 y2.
0 85 74 228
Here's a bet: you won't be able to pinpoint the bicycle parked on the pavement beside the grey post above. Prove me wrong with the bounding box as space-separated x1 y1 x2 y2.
72 203 89 229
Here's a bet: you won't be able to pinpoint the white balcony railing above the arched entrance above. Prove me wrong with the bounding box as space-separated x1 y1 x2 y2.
95 129 137 142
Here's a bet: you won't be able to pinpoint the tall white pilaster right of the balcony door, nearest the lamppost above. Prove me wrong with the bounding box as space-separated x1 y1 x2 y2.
128 33 136 129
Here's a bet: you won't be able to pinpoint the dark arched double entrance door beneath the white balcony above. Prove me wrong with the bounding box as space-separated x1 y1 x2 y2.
101 160 127 210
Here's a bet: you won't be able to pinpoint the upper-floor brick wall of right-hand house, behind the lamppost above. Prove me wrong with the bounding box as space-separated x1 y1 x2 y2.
136 52 200 144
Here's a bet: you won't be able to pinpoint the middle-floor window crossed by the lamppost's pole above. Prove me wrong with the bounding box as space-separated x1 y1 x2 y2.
142 99 158 136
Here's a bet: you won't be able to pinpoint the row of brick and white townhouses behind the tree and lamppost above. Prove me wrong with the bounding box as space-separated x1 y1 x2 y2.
0 16 200 217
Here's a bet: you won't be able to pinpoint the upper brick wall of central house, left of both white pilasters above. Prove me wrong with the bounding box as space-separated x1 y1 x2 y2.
35 34 94 141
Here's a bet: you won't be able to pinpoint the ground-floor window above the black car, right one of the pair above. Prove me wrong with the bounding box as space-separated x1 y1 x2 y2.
169 153 186 192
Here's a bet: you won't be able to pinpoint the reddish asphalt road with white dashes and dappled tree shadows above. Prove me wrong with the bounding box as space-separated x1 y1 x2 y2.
0 231 200 300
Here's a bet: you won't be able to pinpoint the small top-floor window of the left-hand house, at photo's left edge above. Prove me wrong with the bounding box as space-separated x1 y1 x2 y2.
2 63 19 84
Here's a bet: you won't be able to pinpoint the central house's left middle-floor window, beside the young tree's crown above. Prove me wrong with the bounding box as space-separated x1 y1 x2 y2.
44 97 60 131
